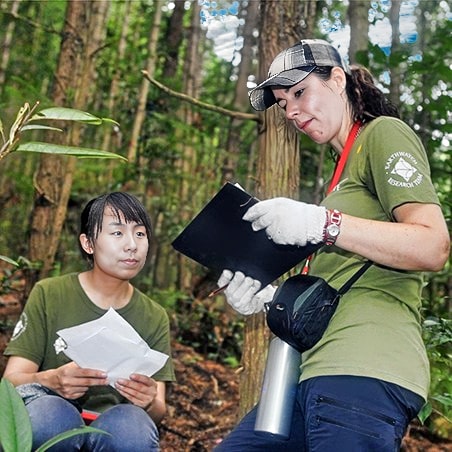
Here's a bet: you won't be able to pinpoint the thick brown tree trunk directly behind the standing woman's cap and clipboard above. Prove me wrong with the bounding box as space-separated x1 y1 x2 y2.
240 0 316 415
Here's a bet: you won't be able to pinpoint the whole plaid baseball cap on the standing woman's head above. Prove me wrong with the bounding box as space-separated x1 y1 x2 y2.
249 39 350 111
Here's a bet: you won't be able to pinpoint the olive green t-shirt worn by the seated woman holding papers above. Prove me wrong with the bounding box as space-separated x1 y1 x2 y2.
4 273 175 412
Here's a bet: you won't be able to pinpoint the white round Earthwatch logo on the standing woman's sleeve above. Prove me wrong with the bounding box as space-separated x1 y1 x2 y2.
385 152 424 188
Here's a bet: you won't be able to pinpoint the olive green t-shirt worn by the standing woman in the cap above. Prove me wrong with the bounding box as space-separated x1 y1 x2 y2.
301 117 438 398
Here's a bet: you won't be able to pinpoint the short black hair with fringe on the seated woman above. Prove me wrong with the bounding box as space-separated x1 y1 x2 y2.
79 192 152 265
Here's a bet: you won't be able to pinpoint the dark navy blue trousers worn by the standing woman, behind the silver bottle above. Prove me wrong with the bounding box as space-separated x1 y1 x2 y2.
215 376 424 452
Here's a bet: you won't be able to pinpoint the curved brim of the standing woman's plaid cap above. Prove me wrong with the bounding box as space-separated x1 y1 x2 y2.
248 66 315 111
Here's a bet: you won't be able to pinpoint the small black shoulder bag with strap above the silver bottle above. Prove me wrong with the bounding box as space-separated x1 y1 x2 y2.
265 261 372 353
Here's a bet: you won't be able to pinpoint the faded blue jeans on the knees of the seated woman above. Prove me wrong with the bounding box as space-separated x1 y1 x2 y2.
18 386 159 452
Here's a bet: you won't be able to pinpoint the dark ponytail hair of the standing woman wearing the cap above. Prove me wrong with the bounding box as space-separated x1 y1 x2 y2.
313 66 400 123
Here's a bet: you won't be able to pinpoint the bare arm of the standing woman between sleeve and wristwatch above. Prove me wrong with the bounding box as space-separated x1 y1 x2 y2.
336 203 450 271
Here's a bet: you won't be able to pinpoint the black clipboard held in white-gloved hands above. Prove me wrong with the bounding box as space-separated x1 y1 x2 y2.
172 182 322 287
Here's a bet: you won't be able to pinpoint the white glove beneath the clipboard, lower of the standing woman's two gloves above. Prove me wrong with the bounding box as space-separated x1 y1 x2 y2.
217 270 276 315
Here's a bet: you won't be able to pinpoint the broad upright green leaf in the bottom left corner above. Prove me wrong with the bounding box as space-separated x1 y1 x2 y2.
0 378 32 452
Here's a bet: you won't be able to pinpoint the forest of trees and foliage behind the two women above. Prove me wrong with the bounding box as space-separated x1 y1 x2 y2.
0 0 452 448
